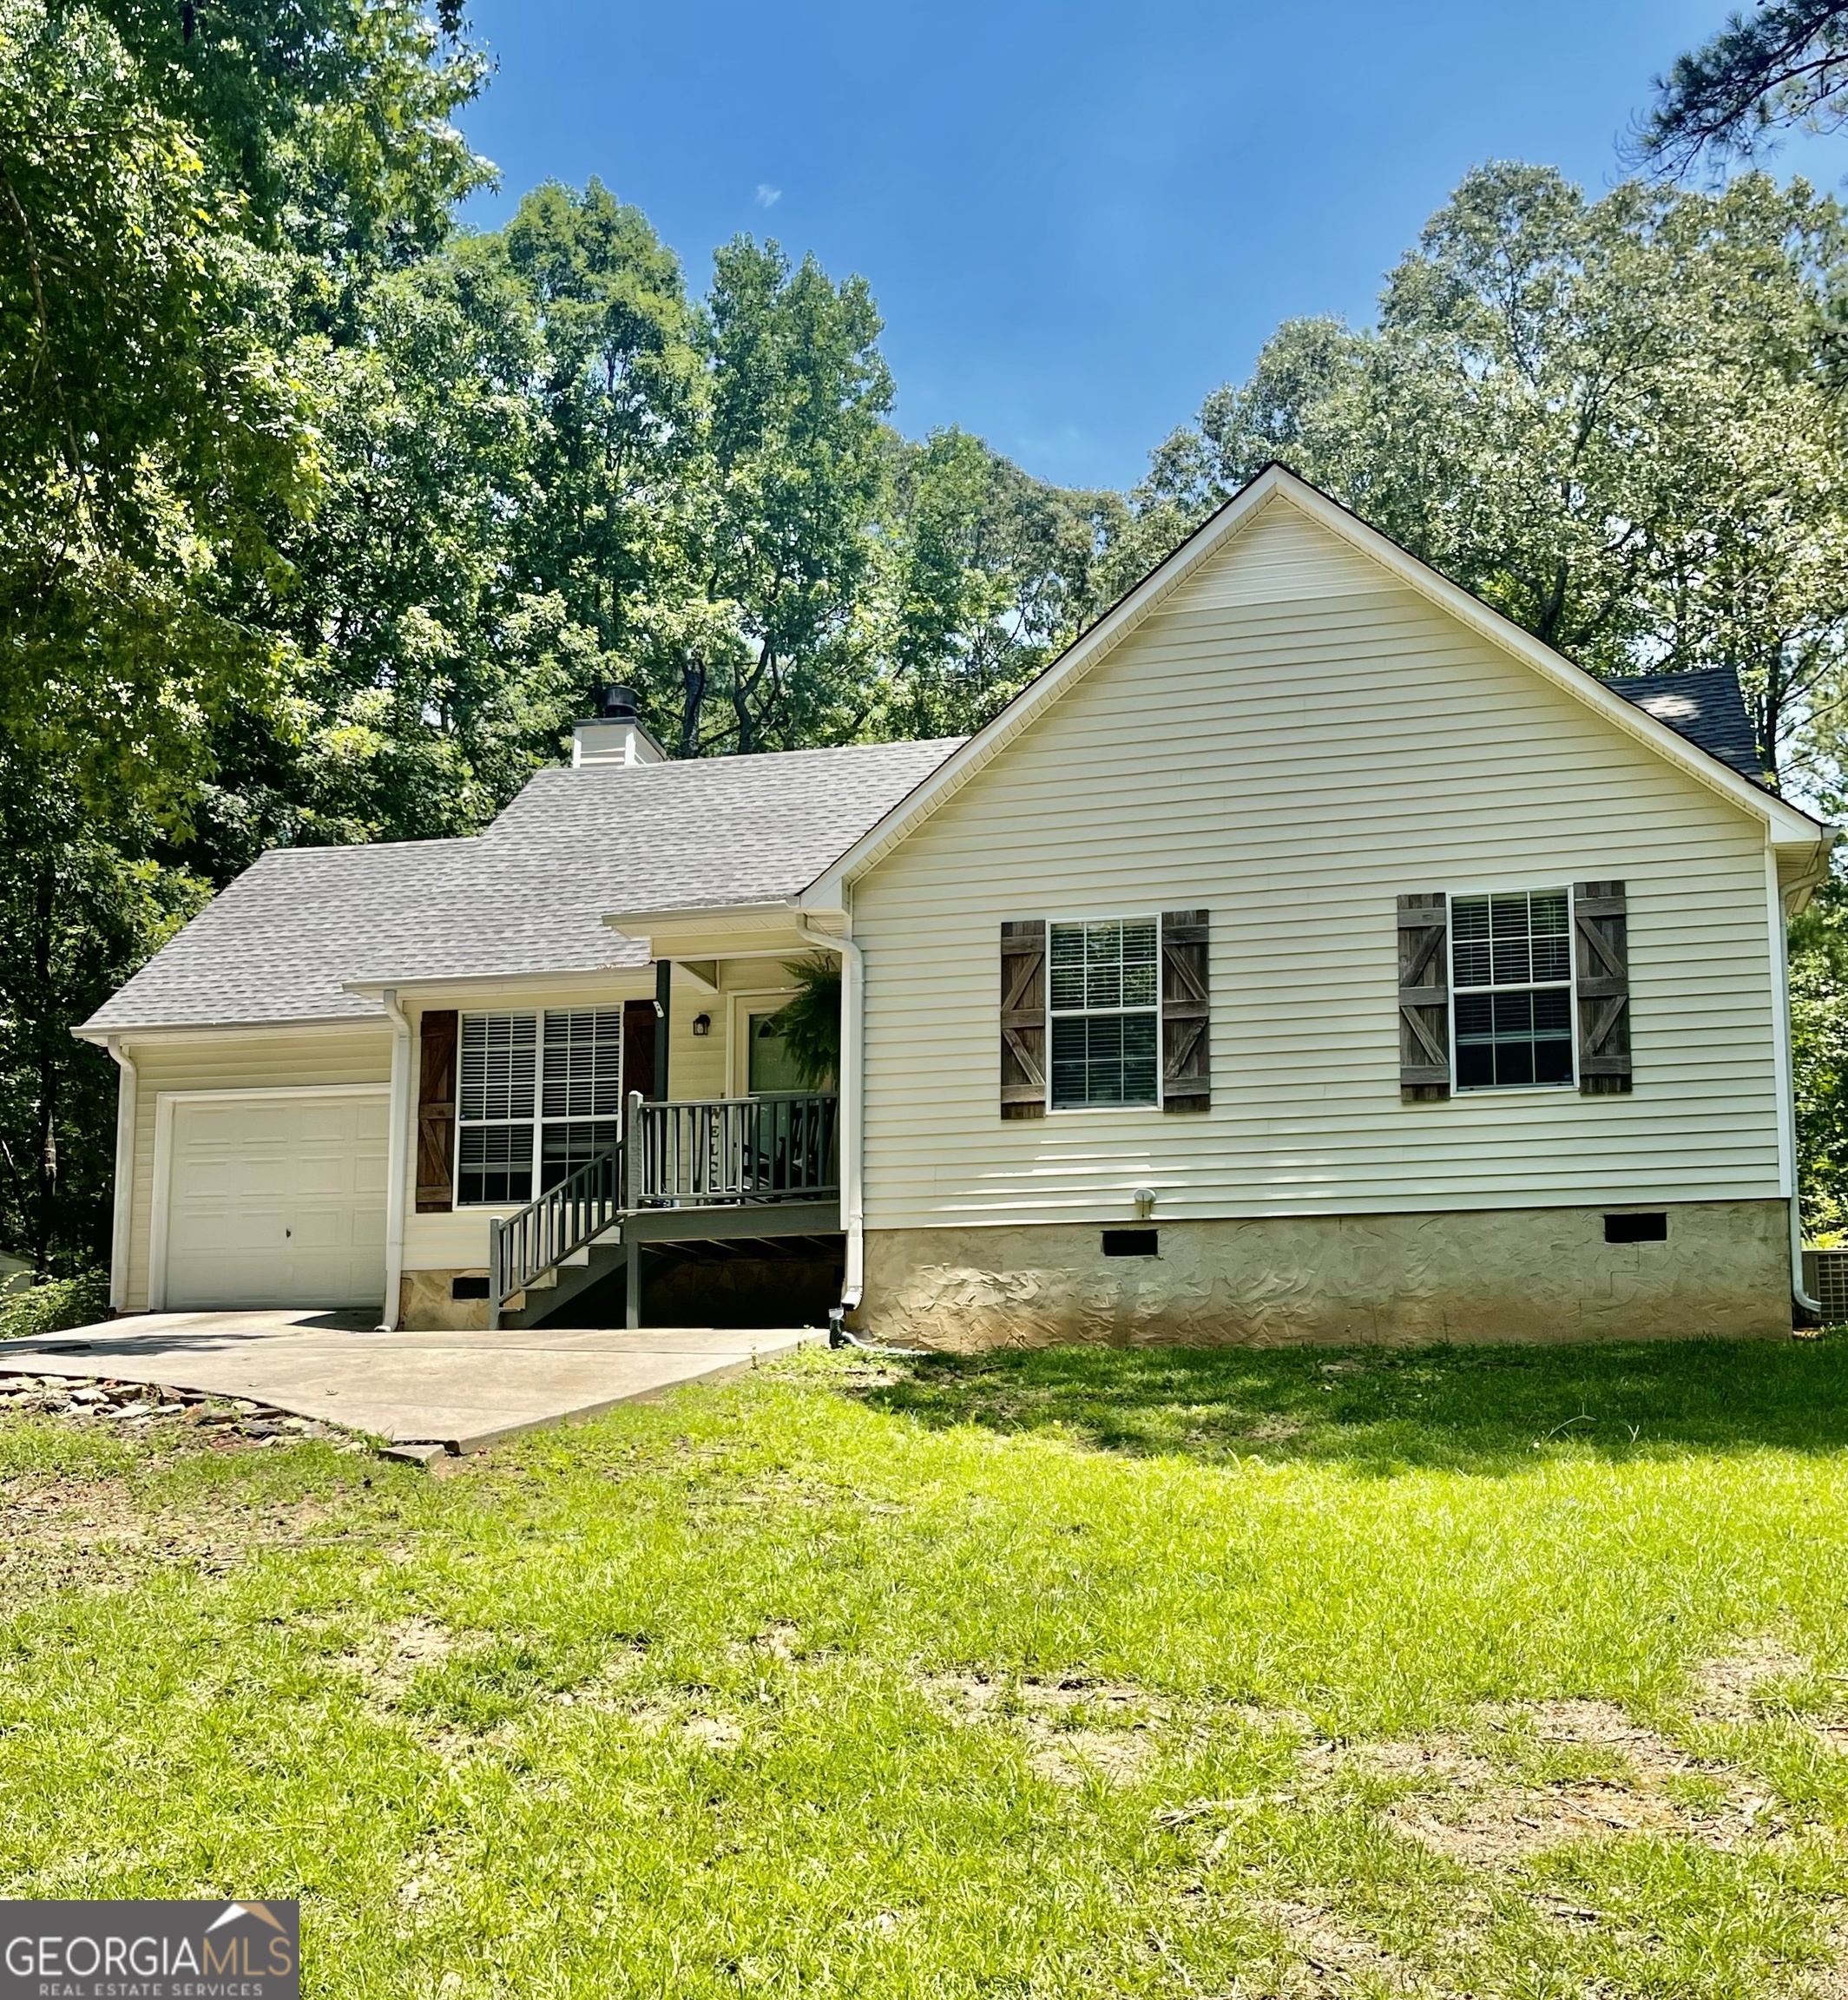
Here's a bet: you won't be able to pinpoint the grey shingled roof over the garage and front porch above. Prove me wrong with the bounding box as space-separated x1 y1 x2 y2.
80 736 962 1036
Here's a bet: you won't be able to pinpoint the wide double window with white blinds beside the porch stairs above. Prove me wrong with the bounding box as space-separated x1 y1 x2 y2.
456 1006 622 1204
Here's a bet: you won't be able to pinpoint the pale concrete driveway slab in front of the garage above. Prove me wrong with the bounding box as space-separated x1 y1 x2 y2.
0 1312 826 1460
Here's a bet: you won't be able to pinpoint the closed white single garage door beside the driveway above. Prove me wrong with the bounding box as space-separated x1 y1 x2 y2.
166 1092 386 1312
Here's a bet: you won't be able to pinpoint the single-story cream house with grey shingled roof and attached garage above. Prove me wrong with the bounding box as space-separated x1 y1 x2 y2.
71 468 1834 1348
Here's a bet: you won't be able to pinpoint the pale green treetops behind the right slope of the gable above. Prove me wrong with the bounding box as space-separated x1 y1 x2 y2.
1138 164 1848 792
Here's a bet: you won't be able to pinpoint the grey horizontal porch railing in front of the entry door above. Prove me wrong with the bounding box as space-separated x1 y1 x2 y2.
628 1092 840 1208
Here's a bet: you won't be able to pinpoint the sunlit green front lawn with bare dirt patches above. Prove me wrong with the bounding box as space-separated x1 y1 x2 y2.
0 1336 1848 2000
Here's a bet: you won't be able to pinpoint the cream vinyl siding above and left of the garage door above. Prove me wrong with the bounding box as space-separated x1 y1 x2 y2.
122 1022 392 1312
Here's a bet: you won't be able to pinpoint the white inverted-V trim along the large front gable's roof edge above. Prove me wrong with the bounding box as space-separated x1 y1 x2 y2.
802 462 1834 910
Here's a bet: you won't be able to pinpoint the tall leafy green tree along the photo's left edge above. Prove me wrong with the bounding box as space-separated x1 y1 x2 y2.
0 0 490 1270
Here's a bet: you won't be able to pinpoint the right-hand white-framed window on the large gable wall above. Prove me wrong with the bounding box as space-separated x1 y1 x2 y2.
1450 888 1572 1090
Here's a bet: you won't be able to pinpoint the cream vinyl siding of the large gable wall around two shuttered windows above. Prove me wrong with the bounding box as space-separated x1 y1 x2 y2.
854 498 1784 1228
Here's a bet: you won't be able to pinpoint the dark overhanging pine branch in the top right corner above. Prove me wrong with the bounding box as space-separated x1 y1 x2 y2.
1636 0 1848 172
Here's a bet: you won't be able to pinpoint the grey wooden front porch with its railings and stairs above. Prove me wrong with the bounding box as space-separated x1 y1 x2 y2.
488 1092 840 1328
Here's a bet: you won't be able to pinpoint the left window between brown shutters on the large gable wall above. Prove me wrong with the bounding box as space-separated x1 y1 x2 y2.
1048 916 1162 1112
